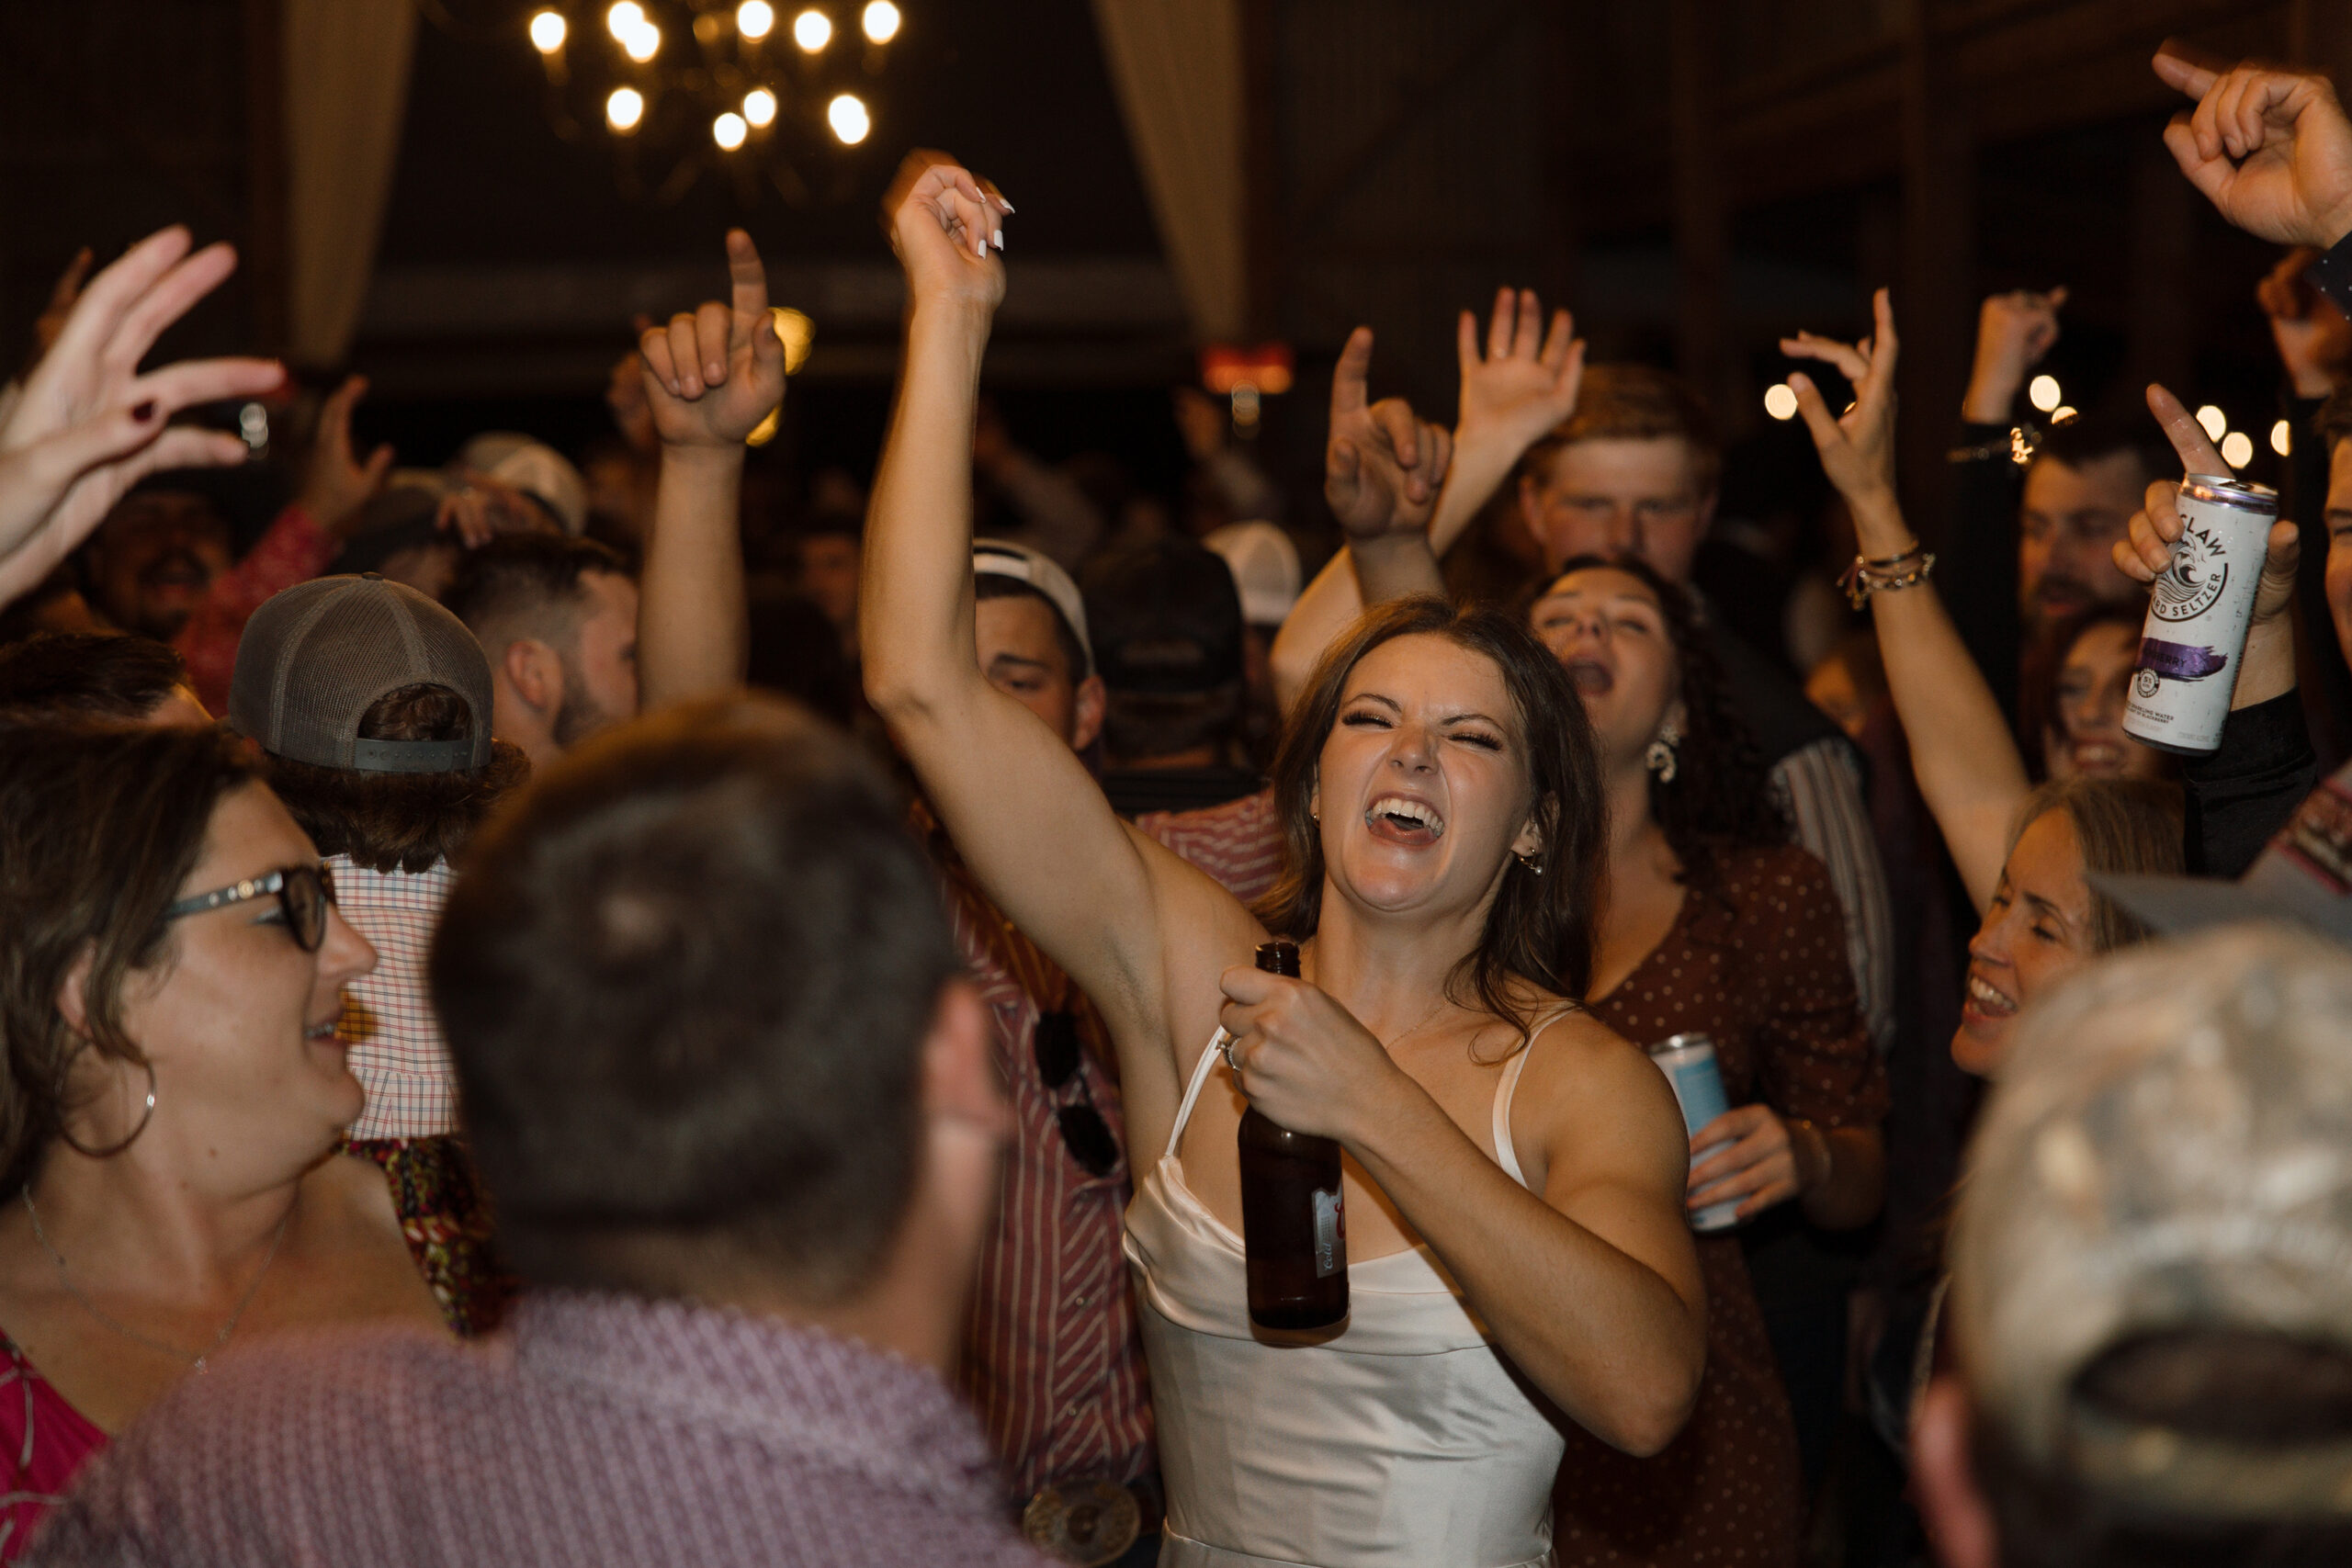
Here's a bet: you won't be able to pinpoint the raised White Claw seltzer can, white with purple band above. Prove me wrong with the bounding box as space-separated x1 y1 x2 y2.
2124 472 2279 755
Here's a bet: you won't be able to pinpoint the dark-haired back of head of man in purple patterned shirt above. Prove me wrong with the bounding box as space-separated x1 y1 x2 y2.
430 698 957 1300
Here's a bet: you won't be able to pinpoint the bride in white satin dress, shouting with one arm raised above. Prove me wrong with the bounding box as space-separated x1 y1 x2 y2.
861 155 1705 1568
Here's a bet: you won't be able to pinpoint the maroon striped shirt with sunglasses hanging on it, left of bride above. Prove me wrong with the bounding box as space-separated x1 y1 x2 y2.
912 802 1158 1497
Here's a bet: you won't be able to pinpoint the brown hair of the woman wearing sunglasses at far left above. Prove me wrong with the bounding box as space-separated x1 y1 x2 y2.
0 719 256 1192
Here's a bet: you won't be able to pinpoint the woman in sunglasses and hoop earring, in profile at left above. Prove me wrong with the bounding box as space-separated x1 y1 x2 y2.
0 724 486 1559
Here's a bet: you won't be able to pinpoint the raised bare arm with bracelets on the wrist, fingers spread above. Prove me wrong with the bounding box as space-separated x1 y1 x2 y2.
1781 289 2030 909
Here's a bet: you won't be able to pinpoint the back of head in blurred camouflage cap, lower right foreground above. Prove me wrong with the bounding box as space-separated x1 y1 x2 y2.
1922 926 2352 1568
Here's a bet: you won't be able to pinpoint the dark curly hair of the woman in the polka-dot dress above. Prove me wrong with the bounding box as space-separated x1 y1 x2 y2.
1545 555 1790 891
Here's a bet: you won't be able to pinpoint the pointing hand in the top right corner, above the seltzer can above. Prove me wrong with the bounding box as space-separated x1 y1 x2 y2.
2154 42 2352 252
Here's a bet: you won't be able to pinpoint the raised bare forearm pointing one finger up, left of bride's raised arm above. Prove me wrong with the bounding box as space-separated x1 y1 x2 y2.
638 228 783 707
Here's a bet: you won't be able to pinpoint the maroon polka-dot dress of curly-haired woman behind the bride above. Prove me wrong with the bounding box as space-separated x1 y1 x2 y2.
1553 844 1886 1568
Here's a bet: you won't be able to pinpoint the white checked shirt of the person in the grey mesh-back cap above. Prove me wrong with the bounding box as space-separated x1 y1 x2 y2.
327 856 457 1143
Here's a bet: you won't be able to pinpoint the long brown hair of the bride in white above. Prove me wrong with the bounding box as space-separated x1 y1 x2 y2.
1259 597 1604 1032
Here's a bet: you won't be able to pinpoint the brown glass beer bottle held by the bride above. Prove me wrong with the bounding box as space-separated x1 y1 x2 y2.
1239 942 1348 1328
